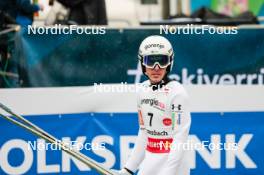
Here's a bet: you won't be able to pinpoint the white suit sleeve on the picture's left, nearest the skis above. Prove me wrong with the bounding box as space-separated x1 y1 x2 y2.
125 94 147 172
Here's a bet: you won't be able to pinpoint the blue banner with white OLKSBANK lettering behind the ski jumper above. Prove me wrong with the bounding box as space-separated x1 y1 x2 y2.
0 112 264 175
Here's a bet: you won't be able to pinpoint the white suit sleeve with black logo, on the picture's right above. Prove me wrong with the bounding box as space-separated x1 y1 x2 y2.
161 91 191 175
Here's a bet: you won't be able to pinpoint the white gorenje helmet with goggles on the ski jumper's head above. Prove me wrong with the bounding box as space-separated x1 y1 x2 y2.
138 35 174 74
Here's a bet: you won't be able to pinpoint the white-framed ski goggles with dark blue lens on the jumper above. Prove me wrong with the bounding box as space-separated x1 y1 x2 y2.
142 55 170 69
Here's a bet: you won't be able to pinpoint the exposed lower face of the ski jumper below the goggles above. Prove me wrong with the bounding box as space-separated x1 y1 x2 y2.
146 64 166 84
